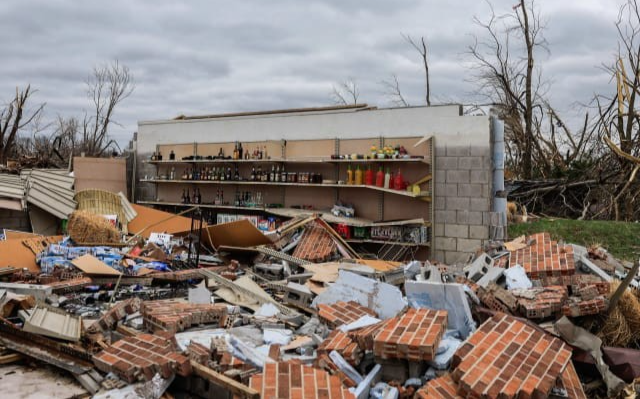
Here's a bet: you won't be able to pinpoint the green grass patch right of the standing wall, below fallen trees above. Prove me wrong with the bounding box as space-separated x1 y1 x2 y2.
509 219 640 261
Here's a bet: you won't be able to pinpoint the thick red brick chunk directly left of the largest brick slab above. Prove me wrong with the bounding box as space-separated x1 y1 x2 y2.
373 308 447 362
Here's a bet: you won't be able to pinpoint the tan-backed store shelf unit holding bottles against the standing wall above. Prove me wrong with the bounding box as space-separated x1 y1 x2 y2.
138 136 434 259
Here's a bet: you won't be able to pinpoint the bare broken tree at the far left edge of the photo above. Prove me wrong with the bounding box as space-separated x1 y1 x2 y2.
0 85 45 164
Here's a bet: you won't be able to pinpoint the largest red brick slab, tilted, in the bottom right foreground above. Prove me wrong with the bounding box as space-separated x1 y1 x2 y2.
452 314 571 398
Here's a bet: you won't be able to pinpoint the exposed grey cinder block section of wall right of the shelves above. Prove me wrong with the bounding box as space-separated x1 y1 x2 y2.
434 139 492 264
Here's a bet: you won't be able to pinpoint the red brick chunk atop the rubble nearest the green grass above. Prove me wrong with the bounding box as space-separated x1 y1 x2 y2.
509 233 576 280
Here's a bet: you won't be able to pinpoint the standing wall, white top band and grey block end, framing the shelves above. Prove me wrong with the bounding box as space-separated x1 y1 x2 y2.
135 106 492 263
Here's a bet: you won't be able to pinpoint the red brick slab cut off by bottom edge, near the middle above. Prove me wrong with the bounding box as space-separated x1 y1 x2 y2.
249 362 355 399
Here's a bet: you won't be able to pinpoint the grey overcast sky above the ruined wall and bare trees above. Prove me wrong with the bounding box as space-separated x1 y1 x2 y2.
0 0 620 145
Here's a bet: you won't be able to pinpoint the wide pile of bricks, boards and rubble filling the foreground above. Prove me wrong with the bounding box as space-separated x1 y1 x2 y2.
0 206 640 399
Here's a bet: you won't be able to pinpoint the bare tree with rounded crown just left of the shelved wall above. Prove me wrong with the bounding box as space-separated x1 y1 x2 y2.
79 60 135 157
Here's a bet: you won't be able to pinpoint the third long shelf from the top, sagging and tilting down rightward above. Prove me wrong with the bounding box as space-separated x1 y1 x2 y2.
137 201 431 227
